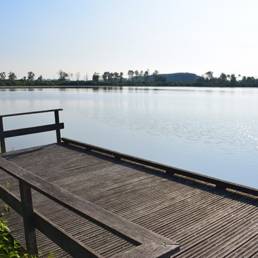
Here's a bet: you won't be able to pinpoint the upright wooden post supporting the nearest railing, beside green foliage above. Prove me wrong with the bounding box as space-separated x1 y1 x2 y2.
19 180 38 256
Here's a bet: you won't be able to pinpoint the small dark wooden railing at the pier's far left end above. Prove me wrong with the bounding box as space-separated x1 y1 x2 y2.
0 109 64 153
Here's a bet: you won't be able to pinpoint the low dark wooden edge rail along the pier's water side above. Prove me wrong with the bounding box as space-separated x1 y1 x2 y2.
62 138 258 198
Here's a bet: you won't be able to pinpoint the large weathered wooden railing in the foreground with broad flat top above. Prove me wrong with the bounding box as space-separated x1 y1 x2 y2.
0 157 179 258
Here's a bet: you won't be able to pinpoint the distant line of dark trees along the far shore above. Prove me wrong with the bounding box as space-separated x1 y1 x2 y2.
0 70 258 87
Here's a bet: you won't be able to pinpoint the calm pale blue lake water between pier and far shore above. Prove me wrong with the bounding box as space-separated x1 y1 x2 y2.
0 87 258 188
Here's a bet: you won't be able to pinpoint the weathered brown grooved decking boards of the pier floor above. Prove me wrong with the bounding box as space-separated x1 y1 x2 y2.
0 145 258 257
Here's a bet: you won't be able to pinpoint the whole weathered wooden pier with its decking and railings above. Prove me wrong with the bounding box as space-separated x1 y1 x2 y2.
0 110 258 258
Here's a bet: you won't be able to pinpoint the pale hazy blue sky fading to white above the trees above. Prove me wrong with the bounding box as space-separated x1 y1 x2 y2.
0 0 258 78
